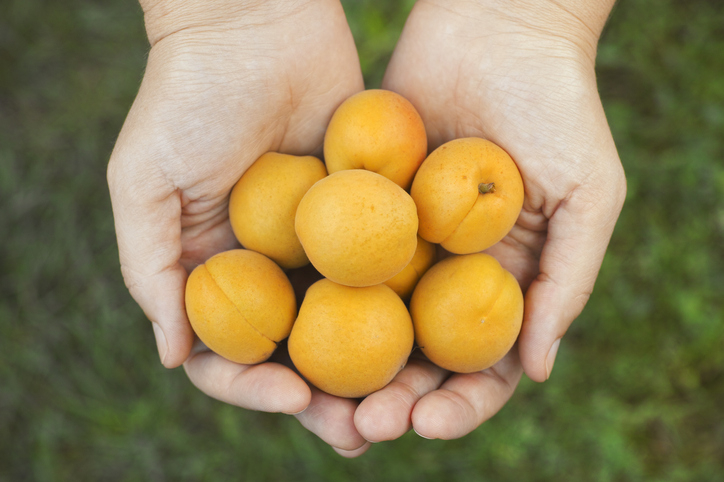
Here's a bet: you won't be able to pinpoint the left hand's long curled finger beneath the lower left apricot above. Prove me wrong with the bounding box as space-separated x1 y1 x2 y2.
184 351 312 414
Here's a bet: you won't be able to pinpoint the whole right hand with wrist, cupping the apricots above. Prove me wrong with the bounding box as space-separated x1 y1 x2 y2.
355 0 626 441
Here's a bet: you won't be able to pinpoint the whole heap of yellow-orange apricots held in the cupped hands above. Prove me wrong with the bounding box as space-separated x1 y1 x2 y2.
186 90 524 398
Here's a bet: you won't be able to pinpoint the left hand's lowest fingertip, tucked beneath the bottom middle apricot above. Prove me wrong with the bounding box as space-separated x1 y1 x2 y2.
295 388 367 452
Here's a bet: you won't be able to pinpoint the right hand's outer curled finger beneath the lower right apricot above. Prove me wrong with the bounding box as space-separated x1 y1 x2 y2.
412 347 523 440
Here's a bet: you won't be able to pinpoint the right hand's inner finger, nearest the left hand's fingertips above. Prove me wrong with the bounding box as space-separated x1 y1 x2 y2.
354 358 450 442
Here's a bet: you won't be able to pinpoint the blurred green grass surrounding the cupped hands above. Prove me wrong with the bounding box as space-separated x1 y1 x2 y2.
0 0 724 481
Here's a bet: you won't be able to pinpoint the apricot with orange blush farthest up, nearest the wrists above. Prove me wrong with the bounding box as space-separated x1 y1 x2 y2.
324 90 427 189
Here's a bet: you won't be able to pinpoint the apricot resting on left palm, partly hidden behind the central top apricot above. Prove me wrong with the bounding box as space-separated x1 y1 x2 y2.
229 152 327 269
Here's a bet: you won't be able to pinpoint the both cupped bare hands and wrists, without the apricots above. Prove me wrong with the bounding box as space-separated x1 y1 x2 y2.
108 0 625 457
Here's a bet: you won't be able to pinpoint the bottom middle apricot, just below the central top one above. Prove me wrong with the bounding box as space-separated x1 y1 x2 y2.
288 279 414 398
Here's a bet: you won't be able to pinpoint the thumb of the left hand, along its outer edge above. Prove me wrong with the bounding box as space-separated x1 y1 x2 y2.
108 122 194 368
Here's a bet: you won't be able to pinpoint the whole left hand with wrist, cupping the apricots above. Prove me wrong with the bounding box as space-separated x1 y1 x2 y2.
108 0 365 456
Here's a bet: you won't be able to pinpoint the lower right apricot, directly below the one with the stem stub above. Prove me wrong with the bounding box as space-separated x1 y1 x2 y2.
410 253 523 373
